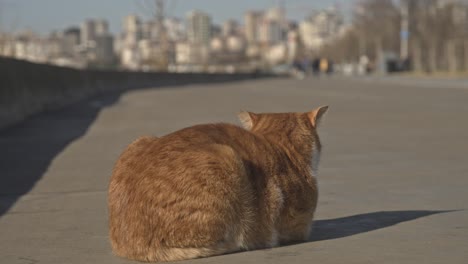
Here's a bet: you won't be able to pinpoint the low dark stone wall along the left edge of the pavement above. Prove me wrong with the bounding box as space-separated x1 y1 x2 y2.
0 57 258 128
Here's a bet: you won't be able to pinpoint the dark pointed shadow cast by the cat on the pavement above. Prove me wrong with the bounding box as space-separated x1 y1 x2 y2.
308 210 456 242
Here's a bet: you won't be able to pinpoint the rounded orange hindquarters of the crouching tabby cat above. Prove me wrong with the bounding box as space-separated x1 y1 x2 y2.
109 124 251 255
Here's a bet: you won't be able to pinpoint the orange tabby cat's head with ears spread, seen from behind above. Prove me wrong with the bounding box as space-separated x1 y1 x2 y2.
239 106 328 174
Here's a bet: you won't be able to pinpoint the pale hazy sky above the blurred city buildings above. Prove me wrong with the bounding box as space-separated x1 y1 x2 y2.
0 0 353 33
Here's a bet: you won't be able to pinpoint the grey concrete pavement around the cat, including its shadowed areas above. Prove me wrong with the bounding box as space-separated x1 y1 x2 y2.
0 78 468 264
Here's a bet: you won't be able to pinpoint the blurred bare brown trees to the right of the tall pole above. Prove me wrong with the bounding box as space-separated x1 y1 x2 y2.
404 0 468 73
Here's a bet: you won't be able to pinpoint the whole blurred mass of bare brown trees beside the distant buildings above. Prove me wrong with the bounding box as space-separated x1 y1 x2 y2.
321 0 468 73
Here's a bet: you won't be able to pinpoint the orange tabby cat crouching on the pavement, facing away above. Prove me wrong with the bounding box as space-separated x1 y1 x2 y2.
108 107 328 261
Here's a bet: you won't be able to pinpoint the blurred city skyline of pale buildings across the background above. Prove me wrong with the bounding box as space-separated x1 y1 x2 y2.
0 1 348 72
